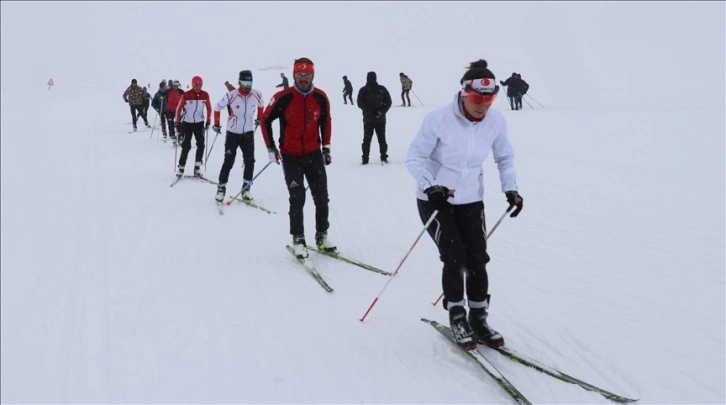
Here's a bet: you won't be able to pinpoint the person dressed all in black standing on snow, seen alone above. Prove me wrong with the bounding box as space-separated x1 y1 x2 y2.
358 72 392 165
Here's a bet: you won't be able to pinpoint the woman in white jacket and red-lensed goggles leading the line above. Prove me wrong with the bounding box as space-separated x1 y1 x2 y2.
406 60 523 349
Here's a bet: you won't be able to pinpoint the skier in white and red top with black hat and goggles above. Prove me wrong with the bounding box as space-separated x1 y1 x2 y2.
212 70 265 203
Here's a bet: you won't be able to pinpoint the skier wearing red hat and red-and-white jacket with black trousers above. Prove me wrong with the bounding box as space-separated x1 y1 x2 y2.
174 76 212 177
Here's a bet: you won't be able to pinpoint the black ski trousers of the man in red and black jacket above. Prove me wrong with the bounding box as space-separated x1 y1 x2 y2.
282 150 330 236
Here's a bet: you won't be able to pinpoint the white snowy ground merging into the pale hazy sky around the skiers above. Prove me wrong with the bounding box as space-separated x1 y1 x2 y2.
0 2 726 404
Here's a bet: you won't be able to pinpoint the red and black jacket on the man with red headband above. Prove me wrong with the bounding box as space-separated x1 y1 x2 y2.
261 86 331 156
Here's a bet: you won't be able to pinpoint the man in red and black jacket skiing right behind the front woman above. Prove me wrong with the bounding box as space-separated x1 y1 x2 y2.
261 58 335 257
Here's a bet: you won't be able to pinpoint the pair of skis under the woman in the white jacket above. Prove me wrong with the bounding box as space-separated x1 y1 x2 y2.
421 318 637 405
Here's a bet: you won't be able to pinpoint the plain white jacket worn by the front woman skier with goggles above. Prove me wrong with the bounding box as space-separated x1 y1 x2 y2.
406 93 517 205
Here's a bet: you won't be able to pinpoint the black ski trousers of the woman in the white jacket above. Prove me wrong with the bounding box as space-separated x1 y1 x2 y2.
417 200 489 310
